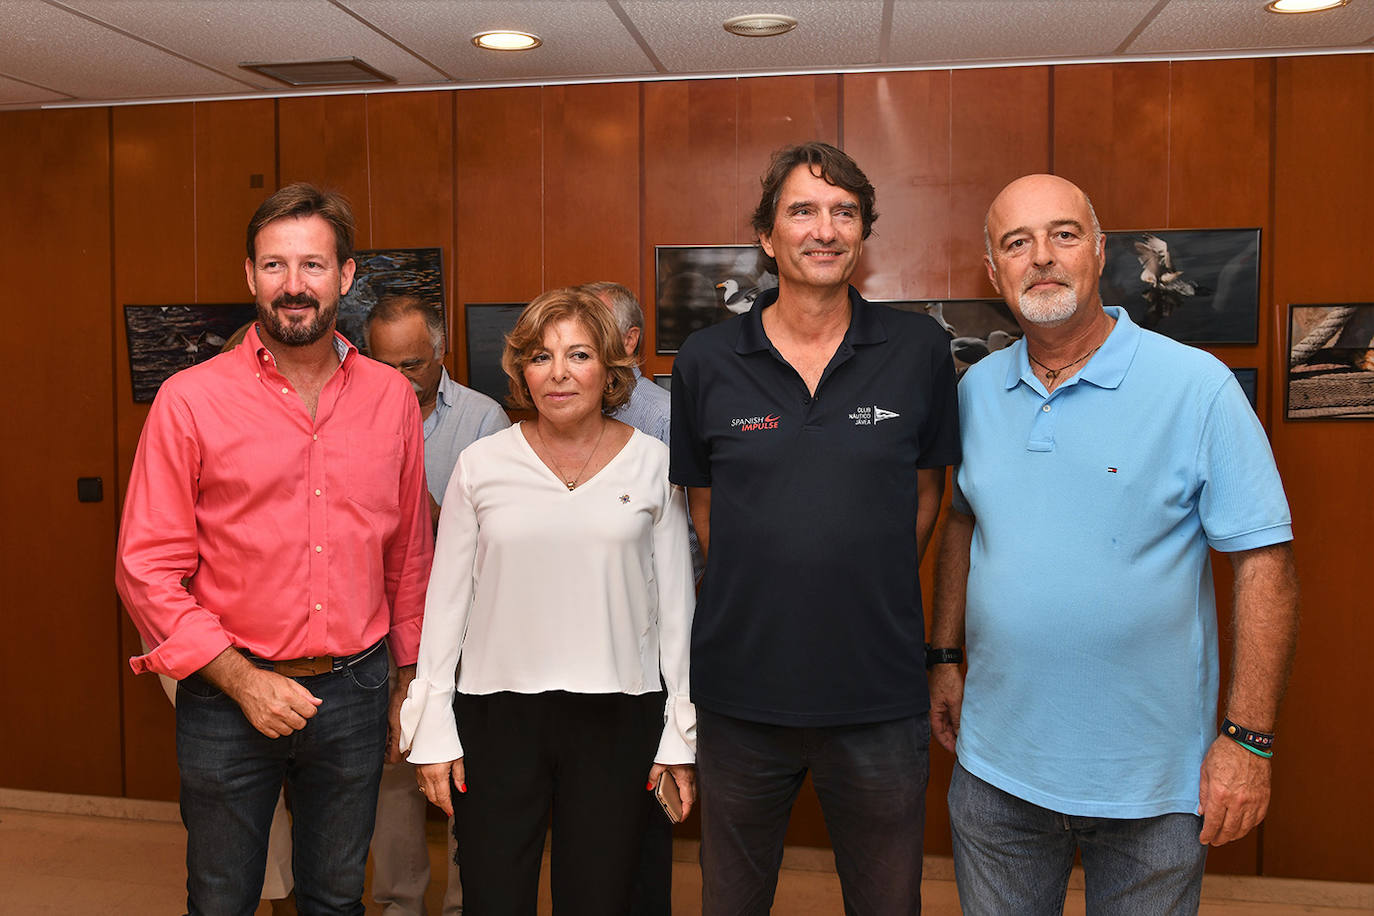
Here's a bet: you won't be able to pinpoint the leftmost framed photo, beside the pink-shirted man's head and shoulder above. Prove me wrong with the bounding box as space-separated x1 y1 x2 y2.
124 302 257 404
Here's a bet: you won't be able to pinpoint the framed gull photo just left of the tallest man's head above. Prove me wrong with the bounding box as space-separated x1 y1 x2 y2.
654 244 778 353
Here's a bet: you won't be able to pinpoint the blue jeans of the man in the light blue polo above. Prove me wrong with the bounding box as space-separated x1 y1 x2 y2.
949 765 1206 916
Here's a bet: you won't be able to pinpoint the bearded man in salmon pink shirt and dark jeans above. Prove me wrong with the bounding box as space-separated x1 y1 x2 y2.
115 184 433 915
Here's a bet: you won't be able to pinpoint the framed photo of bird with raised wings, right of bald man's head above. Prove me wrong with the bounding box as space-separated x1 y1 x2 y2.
1101 229 1260 343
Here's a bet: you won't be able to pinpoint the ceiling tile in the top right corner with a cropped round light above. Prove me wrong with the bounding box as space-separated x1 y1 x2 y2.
1127 0 1374 54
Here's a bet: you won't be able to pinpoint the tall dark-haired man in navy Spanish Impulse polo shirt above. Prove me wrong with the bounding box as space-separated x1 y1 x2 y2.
669 143 959 916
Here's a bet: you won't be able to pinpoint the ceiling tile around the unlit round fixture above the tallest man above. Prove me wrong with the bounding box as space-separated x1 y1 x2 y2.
621 0 882 73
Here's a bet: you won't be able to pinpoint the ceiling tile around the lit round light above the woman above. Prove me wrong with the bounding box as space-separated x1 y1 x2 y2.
339 0 654 81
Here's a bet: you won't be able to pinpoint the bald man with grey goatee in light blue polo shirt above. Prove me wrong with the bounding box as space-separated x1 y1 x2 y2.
929 174 1297 916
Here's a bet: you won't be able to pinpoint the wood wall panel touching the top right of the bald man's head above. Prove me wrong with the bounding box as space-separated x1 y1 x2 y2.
1051 60 1171 229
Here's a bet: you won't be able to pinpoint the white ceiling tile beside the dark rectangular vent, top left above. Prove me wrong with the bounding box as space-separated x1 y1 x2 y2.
62 0 447 89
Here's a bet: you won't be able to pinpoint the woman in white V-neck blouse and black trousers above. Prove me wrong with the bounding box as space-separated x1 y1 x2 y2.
401 290 697 916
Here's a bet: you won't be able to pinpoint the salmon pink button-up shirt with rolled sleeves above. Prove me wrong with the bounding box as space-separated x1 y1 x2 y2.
115 328 434 678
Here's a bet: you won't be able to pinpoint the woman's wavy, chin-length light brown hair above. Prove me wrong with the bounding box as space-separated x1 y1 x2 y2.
502 287 635 413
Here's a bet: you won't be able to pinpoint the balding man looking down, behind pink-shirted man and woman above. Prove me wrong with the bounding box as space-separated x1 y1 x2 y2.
363 294 510 916
